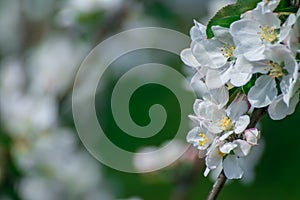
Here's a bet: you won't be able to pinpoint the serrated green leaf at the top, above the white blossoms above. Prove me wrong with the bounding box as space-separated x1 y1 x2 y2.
206 0 261 38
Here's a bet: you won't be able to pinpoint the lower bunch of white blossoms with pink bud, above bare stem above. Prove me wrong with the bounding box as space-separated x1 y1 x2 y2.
187 90 260 179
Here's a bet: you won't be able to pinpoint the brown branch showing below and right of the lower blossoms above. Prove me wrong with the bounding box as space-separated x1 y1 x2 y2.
207 107 267 200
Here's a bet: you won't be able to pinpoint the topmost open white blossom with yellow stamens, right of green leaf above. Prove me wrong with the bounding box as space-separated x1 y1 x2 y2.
230 2 280 61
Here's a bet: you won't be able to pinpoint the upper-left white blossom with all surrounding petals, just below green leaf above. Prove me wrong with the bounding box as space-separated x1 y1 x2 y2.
181 22 264 89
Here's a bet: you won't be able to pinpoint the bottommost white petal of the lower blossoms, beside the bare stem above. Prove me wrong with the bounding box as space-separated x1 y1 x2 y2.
223 155 244 179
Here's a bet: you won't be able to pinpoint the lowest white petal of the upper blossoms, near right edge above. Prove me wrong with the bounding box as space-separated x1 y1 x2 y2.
268 93 299 120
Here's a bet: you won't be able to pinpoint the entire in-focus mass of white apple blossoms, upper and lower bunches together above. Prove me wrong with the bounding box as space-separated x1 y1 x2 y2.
181 0 300 179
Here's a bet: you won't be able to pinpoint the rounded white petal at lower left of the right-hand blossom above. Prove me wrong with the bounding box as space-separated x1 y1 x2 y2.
248 75 277 108
